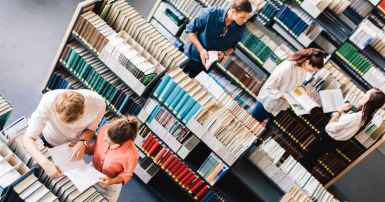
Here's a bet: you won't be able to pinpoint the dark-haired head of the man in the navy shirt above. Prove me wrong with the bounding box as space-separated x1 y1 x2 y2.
229 0 252 25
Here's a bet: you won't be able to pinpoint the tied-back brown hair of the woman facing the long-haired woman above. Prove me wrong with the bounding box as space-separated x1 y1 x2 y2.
287 48 325 69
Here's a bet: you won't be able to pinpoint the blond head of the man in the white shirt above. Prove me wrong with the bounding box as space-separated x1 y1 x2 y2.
55 91 86 124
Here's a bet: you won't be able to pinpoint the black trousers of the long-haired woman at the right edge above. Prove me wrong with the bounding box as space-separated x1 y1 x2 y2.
301 130 345 172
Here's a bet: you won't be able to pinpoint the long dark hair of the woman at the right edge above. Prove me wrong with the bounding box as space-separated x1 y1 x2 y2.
353 88 385 132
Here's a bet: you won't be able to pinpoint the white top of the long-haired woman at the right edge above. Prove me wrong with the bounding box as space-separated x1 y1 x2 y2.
325 113 362 141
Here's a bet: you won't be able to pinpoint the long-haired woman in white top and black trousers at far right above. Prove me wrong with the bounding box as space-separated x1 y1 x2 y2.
301 88 385 172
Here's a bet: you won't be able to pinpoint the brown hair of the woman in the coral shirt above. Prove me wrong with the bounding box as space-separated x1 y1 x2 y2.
107 116 139 145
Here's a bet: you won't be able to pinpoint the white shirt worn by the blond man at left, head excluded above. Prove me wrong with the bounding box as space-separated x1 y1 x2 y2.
26 90 106 146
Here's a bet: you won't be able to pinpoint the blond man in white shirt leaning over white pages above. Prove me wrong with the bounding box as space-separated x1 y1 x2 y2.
23 90 106 177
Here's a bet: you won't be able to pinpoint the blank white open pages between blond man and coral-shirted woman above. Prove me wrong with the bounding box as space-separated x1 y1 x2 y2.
49 143 106 192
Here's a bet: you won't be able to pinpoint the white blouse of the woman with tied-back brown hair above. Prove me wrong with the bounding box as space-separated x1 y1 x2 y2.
257 61 306 113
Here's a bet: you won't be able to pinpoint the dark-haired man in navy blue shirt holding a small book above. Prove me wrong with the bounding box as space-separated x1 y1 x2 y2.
183 0 252 78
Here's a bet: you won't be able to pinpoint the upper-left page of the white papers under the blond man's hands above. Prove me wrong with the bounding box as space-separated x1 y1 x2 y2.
49 143 86 173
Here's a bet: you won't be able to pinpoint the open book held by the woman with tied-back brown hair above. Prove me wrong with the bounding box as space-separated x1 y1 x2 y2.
283 87 319 116
